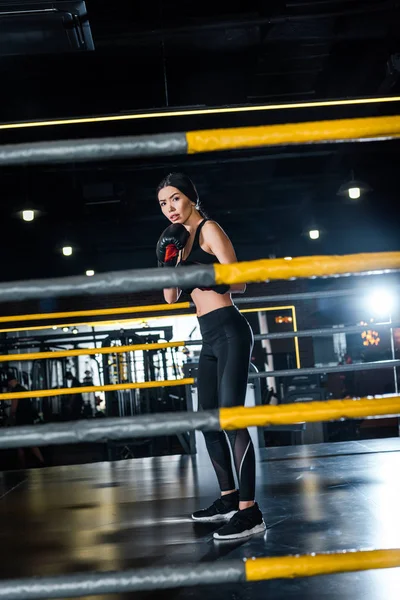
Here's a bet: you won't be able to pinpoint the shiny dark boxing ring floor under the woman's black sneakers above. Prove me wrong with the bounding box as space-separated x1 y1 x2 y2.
0 434 400 600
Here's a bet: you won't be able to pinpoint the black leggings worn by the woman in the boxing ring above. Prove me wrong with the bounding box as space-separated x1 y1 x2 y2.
197 306 255 501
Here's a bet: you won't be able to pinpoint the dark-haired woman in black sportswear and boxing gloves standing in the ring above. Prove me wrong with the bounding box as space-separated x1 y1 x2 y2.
157 173 265 539
